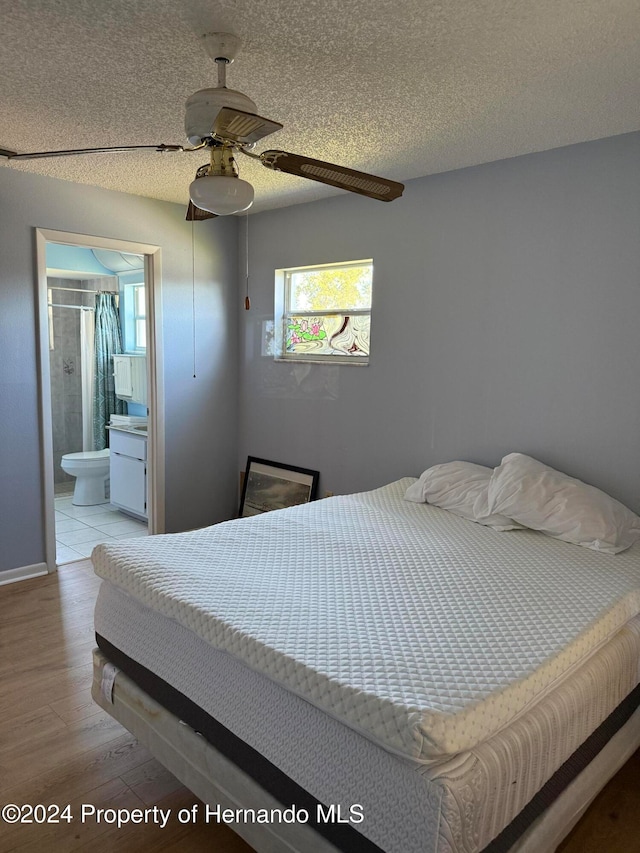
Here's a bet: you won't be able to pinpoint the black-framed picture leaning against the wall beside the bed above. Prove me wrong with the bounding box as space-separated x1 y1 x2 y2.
238 456 320 518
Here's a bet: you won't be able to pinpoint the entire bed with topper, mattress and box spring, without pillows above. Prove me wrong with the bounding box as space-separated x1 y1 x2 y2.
92 478 640 853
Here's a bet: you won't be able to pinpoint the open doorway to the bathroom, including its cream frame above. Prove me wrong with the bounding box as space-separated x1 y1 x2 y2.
36 229 164 572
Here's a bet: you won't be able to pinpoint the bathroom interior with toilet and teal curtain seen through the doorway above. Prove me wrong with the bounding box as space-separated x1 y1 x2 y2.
47 243 148 565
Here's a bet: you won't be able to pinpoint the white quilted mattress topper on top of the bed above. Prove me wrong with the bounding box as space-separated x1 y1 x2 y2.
92 478 640 762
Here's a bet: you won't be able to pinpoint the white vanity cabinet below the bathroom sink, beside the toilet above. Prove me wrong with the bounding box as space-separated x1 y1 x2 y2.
109 428 147 519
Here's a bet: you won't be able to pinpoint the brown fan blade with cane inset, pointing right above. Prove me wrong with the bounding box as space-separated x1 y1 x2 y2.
259 150 404 201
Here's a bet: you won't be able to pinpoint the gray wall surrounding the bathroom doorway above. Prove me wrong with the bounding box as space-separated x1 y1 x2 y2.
0 167 240 571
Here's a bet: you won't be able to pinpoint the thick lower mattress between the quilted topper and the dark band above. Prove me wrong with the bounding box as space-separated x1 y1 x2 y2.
96 582 640 853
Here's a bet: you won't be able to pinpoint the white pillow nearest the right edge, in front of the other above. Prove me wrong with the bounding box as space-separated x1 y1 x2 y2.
487 453 640 554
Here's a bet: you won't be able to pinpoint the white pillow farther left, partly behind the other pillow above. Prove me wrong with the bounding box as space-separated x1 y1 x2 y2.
405 462 520 530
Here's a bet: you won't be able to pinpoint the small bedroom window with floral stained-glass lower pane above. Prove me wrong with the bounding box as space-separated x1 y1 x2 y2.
276 259 373 364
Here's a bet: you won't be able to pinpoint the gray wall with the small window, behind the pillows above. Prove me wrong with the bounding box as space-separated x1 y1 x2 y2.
238 134 640 511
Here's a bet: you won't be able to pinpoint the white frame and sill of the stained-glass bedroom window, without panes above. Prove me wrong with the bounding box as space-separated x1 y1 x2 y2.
274 258 373 367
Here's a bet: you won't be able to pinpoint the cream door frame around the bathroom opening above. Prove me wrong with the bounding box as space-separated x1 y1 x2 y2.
34 228 165 572
